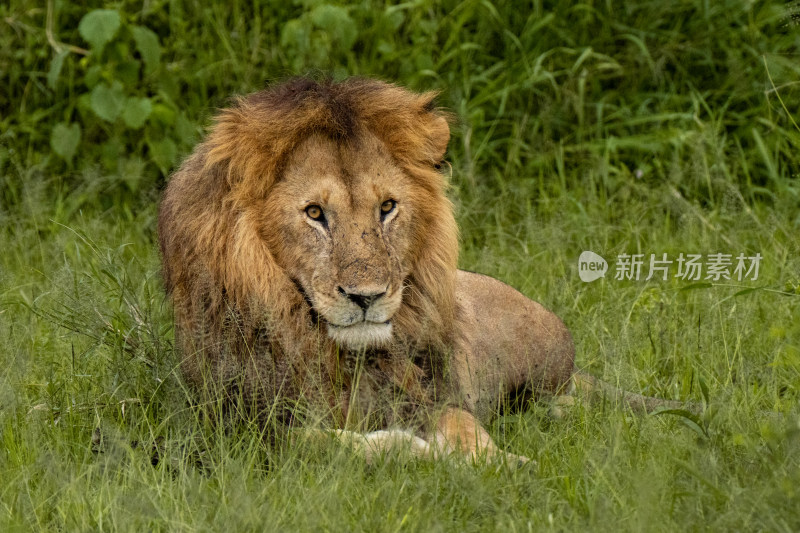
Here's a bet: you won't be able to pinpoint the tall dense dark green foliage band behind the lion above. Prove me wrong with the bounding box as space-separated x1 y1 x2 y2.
0 0 800 203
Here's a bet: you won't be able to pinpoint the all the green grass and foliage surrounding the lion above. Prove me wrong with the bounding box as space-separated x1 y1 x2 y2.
0 0 800 531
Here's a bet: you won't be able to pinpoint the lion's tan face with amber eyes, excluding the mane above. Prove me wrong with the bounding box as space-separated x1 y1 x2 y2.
262 134 424 349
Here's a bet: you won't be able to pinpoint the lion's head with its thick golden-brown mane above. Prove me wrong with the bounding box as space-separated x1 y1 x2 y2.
159 79 458 394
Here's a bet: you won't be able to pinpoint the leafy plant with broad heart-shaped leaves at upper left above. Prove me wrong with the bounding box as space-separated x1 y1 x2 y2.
11 6 196 193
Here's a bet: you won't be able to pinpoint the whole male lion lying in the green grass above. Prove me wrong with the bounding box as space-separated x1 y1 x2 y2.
158 78 688 462
